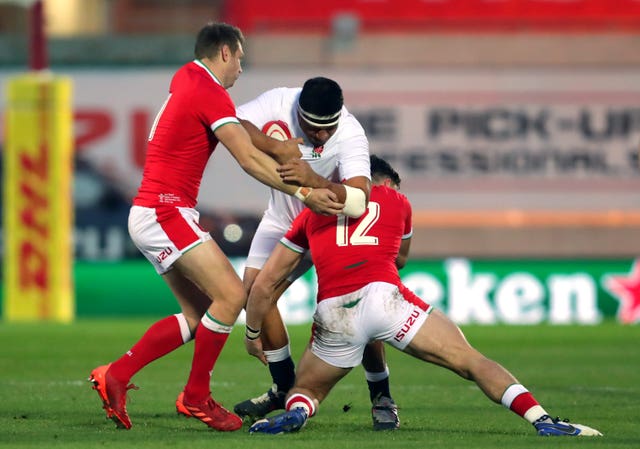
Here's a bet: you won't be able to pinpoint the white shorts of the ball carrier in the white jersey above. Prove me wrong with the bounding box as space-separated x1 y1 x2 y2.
245 216 313 282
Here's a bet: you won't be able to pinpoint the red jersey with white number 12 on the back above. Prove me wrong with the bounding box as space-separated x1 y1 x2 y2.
304 186 412 300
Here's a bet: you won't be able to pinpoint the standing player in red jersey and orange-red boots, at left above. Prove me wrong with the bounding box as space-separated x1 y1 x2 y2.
89 23 343 431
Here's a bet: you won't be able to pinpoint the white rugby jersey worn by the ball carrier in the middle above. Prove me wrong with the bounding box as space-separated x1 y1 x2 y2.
236 87 371 228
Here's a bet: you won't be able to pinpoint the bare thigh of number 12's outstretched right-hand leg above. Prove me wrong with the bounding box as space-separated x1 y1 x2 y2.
404 309 477 372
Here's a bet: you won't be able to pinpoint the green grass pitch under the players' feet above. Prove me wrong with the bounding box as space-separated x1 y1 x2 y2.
0 319 640 449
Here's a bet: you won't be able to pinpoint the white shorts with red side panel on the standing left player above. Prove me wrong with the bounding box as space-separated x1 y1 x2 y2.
129 206 211 274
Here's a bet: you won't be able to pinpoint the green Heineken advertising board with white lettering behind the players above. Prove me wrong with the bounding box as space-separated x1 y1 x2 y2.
57 258 640 325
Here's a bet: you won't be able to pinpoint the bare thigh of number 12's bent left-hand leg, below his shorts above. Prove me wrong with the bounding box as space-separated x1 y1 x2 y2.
295 347 351 402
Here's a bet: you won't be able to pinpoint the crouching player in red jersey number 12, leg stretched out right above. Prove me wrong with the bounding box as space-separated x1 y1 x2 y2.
245 156 601 436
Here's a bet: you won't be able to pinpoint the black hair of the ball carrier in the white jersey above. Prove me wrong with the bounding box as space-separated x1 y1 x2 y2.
298 76 344 117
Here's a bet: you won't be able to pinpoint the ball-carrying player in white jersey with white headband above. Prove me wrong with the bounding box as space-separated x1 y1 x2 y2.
234 77 399 429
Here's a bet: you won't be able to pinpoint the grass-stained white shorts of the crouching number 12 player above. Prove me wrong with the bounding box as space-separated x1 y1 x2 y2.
311 282 432 368
